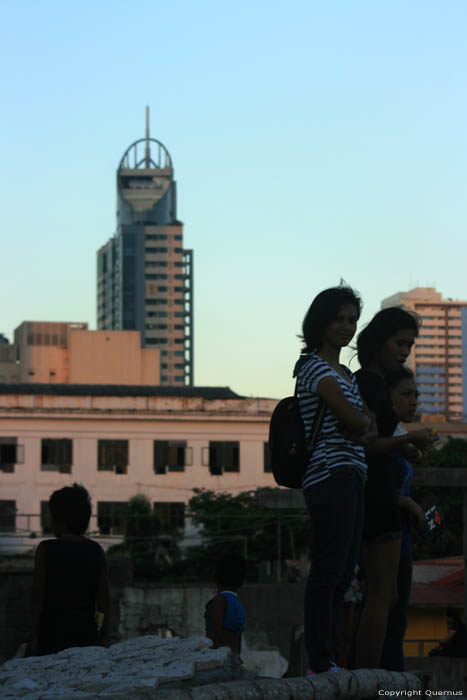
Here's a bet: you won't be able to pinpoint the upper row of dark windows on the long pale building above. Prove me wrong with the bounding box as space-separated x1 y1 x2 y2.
0 438 271 475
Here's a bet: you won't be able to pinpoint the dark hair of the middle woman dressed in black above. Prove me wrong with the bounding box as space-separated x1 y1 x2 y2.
357 306 420 368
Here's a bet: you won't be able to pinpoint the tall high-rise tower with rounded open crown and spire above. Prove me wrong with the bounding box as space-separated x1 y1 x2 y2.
97 107 193 386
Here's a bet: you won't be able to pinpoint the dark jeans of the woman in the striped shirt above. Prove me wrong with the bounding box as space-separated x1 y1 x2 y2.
304 467 364 672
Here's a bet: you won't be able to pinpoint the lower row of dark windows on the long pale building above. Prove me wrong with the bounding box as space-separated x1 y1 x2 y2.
0 500 185 535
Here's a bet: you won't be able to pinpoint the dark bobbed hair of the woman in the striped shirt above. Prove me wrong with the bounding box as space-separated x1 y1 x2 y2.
299 282 362 352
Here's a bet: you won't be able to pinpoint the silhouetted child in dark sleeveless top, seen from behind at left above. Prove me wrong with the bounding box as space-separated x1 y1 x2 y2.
28 484 109 655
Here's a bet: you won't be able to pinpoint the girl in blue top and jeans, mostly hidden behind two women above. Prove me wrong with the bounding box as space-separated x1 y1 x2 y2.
381 367 426 671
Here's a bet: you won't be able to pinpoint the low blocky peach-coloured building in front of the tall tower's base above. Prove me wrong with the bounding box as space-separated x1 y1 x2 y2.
11 321 160 386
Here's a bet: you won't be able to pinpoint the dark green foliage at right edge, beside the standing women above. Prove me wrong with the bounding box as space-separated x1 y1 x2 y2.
412 437 467 559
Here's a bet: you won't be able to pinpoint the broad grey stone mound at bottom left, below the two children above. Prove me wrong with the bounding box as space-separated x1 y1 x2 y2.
0 635 234 700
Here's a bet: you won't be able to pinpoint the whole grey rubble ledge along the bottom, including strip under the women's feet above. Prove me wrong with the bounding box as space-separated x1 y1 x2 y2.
0 635 420 700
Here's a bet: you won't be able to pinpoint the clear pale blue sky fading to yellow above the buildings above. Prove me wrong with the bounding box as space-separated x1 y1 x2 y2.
0 0 467 398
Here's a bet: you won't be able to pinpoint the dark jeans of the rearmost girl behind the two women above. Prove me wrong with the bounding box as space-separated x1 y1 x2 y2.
381 538 412 671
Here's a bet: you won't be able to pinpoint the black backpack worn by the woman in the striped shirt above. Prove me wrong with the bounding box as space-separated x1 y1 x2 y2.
269 385 326 489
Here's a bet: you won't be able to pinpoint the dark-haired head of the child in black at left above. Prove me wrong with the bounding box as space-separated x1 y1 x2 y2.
49 484 91 537
